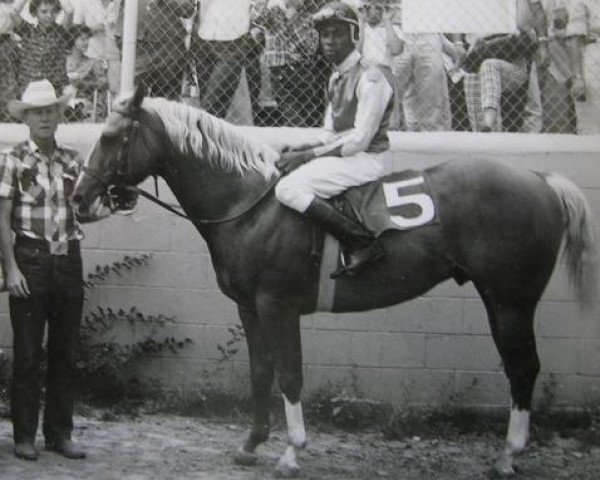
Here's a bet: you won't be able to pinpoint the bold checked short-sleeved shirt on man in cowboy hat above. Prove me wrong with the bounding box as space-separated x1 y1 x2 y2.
0 140 83 255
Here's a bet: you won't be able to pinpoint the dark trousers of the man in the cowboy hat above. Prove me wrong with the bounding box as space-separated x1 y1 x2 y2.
9 240 83 443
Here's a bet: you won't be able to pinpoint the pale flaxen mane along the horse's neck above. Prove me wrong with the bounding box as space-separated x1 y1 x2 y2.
143 98 279 178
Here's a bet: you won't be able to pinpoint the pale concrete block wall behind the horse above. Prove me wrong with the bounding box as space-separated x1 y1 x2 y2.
0 125 600 408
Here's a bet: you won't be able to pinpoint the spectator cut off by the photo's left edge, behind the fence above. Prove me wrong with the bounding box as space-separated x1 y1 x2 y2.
0 0 27 122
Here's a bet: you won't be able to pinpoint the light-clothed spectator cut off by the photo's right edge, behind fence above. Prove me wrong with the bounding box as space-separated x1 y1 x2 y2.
566 0 600 134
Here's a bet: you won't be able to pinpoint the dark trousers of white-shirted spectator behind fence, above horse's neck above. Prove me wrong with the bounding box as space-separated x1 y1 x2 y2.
191 34 262 124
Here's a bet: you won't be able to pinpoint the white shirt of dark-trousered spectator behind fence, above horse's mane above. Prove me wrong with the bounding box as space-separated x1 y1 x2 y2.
198 0 250 41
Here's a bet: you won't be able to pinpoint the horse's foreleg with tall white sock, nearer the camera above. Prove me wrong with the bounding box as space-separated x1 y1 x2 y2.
259 300 306 478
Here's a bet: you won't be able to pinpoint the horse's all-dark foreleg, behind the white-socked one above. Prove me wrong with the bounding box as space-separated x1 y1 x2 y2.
235 306 274 465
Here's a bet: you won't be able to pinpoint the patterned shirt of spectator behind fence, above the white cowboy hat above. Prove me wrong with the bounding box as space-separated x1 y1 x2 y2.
15 22 69 95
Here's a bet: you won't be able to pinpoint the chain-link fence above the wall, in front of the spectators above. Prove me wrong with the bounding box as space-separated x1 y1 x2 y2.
0 0 600 134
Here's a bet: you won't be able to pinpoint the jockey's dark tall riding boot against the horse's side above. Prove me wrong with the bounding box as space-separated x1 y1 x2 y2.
304 198 385 278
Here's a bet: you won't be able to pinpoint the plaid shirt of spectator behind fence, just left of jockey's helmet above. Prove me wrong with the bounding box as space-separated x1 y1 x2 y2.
250 0 319 67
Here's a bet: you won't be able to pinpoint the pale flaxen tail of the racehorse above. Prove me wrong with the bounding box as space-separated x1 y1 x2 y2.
545 172 598 305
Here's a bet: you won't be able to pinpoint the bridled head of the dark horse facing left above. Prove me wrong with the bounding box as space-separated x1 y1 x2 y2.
71 87 159 219
